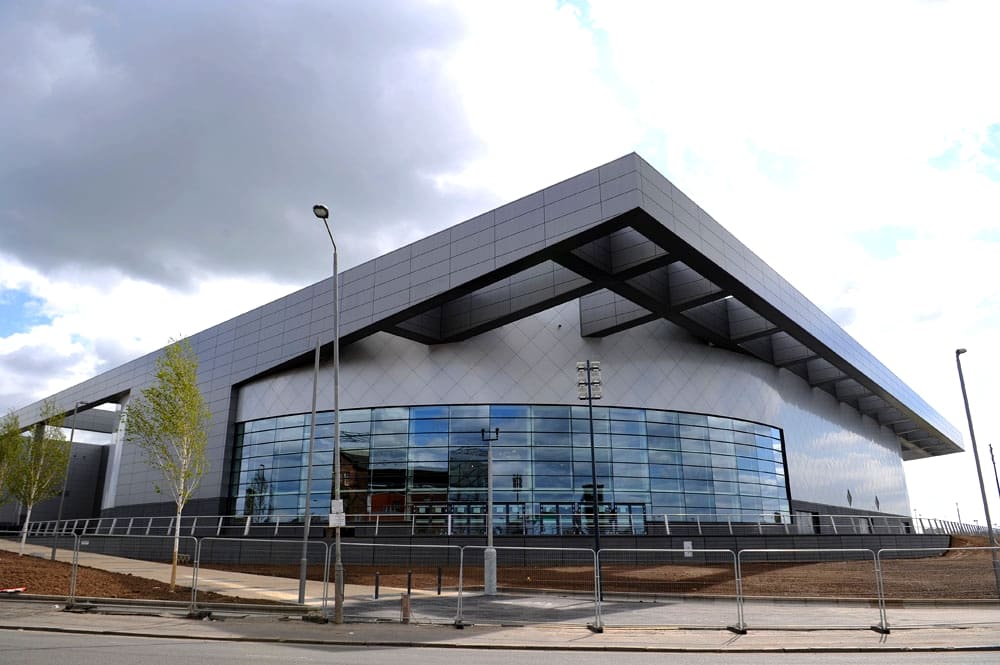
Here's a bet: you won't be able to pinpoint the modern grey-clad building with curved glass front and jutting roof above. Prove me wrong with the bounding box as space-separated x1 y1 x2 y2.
7 154 962 534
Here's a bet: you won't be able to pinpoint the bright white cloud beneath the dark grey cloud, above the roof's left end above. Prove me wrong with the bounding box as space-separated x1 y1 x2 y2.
0 256 294 412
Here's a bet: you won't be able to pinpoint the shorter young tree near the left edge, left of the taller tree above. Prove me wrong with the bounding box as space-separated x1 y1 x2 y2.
4 401 70 554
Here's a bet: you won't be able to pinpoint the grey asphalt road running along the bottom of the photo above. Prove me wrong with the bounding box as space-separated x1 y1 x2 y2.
0 630 1000 665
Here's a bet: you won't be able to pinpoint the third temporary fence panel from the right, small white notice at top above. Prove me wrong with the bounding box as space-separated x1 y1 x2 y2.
598 549 740 628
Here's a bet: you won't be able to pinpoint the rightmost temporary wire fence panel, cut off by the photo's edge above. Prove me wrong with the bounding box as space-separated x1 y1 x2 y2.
878 547 1000 628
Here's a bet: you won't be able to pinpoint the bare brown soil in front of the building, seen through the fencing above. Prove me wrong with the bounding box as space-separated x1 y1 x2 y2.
0 537 996 602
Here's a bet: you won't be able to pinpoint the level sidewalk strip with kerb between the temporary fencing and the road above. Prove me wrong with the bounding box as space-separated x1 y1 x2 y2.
0 601 1000 653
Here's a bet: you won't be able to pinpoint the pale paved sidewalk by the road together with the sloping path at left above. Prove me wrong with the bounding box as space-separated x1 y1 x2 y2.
0 540 1000 651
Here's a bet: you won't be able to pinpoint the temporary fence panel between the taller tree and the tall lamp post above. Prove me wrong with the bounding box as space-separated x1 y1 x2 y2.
197 536 329 611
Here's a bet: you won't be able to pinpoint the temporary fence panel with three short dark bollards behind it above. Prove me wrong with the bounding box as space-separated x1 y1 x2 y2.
330 543 461 624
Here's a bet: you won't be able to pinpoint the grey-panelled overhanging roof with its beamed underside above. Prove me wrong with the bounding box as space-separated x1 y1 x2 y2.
15 153 962 459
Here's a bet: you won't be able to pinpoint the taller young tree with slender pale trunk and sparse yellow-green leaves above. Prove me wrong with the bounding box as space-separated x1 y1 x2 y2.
125 340 211 591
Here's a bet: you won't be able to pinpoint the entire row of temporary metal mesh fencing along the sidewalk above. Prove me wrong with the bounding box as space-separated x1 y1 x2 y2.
0 532 1000 631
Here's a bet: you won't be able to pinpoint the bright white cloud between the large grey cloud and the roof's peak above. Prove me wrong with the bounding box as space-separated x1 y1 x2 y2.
438 2 641 203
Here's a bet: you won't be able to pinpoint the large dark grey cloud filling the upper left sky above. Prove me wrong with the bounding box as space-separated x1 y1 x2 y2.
0 1 493 286
